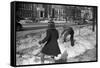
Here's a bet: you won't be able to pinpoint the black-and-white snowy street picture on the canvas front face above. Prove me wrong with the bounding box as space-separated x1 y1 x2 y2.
10 2 98 66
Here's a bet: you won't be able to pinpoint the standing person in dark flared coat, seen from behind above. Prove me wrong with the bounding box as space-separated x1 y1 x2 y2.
39 21 61 63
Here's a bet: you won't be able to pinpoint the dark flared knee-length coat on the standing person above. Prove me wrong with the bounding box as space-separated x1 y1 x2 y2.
41 29 61 56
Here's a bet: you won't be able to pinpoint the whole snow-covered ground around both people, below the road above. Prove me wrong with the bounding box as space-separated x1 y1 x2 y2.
16 26 96 65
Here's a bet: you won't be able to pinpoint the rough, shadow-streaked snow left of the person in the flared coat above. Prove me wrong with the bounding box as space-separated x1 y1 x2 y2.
16 32 46 65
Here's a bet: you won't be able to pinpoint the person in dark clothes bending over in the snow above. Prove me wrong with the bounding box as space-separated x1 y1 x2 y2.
61 25 74 46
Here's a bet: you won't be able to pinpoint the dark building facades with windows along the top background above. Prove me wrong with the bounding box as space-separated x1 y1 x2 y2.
16 2 93 21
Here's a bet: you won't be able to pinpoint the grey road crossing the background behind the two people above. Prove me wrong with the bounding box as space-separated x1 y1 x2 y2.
18 23 90 31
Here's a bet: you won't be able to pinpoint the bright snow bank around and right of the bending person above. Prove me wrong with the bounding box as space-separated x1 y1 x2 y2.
58 27 96 59
